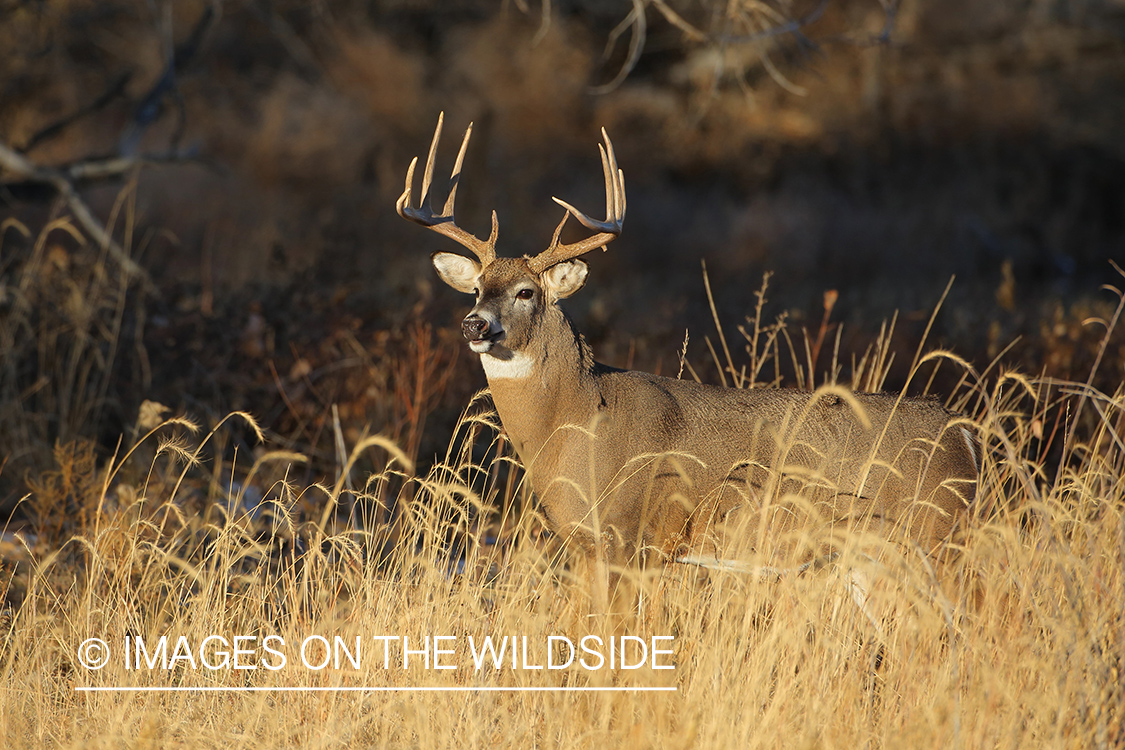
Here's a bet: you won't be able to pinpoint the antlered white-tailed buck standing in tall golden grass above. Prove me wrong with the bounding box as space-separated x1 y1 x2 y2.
397 113 978 580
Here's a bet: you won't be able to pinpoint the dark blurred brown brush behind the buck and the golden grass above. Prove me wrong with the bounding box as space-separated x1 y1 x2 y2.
0 0 1125 510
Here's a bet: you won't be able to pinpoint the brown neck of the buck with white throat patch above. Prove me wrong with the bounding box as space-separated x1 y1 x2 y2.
480 306 597 469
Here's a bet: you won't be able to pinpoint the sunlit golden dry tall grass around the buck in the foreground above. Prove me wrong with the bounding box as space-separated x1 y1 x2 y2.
0 231 1125 748
